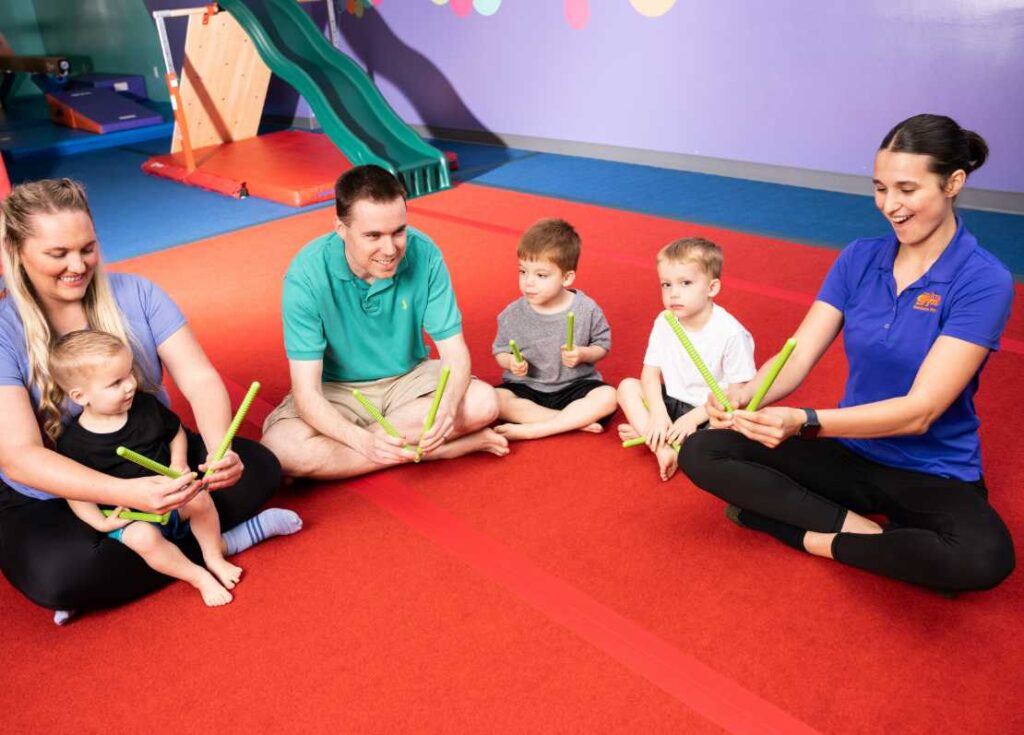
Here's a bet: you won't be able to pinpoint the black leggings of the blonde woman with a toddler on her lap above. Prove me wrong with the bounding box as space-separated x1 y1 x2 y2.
0 433 281 610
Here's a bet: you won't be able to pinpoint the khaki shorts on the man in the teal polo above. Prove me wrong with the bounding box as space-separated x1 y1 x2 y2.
263 360 441 434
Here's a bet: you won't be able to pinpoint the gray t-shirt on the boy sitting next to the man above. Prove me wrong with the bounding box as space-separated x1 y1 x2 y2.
492 291 611 393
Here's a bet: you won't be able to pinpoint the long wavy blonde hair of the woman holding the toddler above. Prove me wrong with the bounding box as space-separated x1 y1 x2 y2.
0 178 136 444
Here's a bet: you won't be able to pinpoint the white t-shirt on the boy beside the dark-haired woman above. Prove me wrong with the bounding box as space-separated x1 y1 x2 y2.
643 304 758 405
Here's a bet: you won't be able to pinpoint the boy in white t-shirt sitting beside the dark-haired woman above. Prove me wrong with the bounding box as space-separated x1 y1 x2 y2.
618 237 757 480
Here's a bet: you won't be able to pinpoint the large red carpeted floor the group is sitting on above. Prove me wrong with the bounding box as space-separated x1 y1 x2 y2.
0 185 1024 733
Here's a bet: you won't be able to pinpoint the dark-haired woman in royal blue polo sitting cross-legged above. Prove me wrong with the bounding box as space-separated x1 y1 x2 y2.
680 115 1014 591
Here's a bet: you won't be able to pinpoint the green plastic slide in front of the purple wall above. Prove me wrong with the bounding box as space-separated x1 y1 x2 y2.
217 0 452 198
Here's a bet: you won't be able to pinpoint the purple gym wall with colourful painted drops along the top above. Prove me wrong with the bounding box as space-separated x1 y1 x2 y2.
329 0 1024 192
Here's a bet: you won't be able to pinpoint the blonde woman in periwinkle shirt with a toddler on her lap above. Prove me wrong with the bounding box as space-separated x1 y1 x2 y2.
0 179 301 622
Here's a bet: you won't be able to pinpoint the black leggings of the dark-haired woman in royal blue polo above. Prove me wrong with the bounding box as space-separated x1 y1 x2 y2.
680 430 1015 591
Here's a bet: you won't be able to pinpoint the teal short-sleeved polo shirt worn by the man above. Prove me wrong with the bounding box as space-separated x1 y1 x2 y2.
282 227 462 383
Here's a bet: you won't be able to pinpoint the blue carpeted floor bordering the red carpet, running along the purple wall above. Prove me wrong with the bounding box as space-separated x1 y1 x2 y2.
9 131 1024 277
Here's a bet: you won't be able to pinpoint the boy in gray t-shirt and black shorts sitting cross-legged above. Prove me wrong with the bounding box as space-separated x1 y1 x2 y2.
493 219 616 439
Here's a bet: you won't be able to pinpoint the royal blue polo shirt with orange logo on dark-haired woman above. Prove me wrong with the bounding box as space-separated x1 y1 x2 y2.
817 218 1014 481
